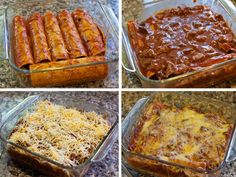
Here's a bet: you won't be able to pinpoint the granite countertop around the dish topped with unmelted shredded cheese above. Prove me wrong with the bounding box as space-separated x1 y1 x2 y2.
0 92 119 177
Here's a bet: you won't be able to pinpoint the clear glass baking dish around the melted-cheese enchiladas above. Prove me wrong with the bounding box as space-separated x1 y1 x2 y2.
122 92 236 177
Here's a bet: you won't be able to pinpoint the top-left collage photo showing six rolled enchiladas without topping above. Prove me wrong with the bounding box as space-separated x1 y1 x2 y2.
0 0 119 88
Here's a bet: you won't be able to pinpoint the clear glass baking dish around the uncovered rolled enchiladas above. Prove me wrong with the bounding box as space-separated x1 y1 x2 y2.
0 0 119 87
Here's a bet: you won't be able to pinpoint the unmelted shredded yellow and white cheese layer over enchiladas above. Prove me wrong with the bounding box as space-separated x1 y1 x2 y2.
9 101 110 166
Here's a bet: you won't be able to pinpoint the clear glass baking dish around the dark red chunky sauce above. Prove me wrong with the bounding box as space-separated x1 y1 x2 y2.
122 0 236 88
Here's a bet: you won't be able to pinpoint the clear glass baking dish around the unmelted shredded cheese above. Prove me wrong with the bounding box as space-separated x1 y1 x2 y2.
0 94 118 177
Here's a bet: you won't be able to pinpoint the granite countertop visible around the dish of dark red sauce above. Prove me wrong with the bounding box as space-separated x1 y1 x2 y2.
122 0 236 88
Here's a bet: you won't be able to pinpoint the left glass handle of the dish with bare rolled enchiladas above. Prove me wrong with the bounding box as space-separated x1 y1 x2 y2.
0 8 8 60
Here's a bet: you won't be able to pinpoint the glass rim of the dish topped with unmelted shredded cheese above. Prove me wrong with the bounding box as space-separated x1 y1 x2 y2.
0 92 119 170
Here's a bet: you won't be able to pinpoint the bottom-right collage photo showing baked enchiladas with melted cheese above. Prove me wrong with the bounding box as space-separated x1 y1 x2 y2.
121 91 236 177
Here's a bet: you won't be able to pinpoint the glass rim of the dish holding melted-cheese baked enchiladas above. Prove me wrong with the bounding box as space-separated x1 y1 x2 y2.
121 92 236 174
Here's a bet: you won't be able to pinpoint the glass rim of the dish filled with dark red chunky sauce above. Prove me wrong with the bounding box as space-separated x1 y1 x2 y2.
122 0 236 84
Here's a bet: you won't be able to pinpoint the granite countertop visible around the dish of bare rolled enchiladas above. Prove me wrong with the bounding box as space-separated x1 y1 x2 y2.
0 0 119 88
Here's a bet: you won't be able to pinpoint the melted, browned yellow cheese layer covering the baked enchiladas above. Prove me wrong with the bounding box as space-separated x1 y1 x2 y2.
131 106 232 169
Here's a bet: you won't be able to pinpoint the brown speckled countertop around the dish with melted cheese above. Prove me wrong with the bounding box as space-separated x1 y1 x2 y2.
122 92 236 177
